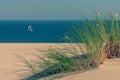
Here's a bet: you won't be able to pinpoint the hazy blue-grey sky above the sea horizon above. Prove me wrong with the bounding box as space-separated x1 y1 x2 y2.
0 0 120 20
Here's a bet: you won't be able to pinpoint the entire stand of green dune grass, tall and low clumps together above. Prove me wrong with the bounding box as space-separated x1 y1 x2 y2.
16 11 120 80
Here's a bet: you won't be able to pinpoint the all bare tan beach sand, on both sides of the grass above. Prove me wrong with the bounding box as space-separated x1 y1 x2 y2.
0 43 120 80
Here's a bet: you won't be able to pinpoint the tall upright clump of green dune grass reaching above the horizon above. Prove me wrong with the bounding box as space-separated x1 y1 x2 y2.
70 10 120 67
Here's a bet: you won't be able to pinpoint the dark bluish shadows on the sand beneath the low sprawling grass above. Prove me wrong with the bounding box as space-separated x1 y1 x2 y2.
22 54 88 80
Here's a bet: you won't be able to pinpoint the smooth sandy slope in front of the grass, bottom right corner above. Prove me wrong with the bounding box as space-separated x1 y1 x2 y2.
59 59 120 80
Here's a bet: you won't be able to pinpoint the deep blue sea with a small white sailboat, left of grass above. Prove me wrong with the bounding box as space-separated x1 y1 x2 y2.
0 20 79 43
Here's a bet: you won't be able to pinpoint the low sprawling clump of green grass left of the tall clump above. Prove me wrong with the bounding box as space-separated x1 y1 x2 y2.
18 44 88 80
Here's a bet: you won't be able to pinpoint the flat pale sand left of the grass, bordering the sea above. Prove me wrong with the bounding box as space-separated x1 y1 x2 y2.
0 43 67 80
